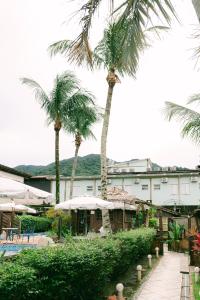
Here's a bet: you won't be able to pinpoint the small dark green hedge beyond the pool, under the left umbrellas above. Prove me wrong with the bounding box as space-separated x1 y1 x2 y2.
18 215 52 232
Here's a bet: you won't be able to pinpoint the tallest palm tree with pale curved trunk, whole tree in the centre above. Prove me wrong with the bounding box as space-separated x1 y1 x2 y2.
50 19 150 232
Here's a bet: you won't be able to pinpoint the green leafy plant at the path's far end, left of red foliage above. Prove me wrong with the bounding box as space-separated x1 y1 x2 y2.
167 222 184 251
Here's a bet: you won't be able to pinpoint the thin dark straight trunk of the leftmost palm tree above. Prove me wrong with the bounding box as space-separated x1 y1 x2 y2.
55 128 60 204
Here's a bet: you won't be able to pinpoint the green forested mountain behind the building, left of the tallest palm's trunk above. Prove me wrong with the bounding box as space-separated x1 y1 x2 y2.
15 154 100 176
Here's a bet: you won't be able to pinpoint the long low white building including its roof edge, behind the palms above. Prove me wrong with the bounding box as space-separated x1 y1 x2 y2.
29 170 200 207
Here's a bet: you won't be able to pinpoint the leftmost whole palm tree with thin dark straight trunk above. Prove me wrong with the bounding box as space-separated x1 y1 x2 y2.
21 71 95 203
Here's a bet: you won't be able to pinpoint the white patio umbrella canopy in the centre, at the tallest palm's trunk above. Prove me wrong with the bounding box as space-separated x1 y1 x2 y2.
55 196 114 210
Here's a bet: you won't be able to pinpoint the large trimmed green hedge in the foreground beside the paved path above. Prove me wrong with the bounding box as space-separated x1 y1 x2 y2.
0 229 155 300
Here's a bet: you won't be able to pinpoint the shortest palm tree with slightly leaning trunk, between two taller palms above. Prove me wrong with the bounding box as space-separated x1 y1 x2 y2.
64 100 100 198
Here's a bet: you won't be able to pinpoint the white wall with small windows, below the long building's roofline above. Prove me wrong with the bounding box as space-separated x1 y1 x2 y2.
52 174 200 206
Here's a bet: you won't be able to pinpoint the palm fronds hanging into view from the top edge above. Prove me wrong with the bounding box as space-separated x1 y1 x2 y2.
54 0 176 66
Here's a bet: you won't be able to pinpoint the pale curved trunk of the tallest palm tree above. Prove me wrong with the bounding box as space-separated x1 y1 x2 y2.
101 70 116 232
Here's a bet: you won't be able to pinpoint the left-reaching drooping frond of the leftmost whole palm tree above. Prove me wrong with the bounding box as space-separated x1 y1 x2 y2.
20 78 50 109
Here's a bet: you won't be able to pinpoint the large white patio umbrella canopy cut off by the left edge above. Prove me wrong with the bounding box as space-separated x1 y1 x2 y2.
0 177 53 205
